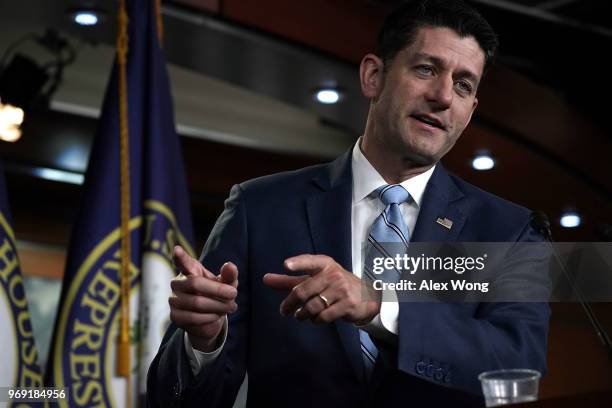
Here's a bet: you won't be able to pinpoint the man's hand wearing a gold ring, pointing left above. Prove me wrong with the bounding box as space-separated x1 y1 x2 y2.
263 255 380 324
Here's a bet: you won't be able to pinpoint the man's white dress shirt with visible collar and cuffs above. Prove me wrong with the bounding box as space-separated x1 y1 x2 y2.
184 138 435 375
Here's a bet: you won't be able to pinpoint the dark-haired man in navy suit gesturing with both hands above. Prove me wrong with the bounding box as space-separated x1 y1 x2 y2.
147 0 549 407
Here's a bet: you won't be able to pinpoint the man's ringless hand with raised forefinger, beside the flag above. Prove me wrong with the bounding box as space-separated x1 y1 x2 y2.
168 245 238 352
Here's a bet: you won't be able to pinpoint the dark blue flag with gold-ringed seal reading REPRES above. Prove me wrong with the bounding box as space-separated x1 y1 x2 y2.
46 0 193 407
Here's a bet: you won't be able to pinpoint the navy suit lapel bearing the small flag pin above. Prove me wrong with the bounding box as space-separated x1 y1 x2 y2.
411 163 468 242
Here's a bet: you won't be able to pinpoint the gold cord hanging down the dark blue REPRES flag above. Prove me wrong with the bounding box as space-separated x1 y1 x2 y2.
117 0 132 408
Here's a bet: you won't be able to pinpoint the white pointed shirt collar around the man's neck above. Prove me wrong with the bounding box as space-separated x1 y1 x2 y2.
351 138 436 207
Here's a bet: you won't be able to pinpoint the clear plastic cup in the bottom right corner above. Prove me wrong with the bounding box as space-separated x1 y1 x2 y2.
478 368 542 407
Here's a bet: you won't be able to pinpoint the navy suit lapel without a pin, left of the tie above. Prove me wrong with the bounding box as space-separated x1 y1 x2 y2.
306 150 363 380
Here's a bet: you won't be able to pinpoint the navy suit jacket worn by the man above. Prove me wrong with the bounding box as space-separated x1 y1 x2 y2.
147 151 549 407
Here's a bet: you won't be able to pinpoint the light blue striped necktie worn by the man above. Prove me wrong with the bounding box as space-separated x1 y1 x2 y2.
359 184 410 380
